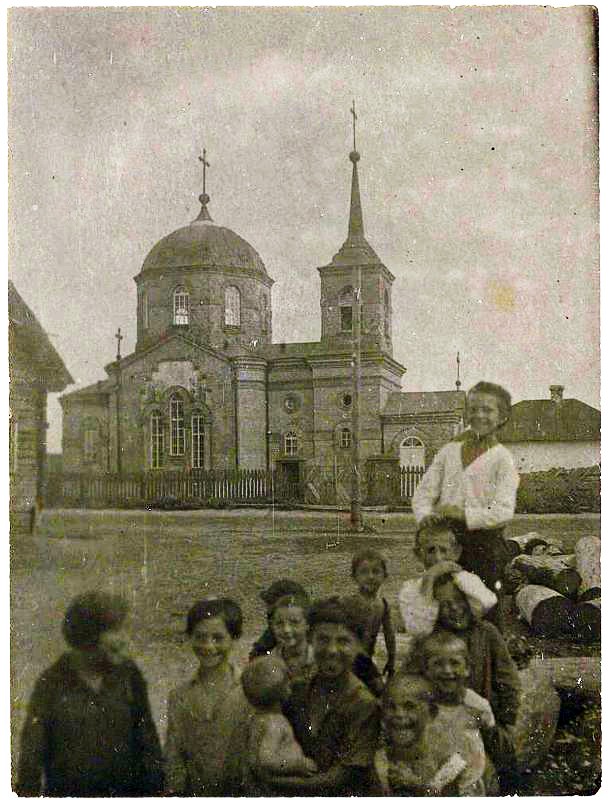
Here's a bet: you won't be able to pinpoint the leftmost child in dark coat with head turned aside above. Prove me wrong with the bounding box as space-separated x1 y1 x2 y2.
15 592 163 797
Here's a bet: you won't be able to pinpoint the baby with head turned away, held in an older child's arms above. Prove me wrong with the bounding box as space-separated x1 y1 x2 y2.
241 656 317 797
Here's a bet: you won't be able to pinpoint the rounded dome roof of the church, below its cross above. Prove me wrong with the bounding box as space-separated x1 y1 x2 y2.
142 198 267 275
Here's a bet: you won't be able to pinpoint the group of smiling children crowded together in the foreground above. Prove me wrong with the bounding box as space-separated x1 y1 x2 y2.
16 384 520 797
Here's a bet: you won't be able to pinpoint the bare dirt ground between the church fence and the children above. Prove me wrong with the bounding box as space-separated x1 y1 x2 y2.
11 509 600 795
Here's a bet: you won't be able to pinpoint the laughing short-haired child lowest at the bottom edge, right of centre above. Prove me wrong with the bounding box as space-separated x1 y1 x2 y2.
374 675 476 797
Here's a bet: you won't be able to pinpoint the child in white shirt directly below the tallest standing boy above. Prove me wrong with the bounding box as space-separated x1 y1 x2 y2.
398 517 497 637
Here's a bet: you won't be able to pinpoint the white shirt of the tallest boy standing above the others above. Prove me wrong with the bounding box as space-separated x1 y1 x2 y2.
412 442 520 530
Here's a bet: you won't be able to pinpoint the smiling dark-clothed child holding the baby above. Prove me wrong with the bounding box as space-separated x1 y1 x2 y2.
274 597 380 796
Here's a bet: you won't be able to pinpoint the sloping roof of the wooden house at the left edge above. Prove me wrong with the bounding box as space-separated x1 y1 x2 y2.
8 281 74 392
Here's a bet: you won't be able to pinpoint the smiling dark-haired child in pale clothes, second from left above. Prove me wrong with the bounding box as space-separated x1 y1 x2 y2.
165 597 248 797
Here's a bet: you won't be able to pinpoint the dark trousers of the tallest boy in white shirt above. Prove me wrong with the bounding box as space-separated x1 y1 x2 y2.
459 528 511 631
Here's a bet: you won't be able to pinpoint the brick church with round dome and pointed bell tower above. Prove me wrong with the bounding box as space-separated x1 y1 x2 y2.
61 142 464 494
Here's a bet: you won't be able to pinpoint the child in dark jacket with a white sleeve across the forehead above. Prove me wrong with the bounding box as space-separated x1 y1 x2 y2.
406 574 520 780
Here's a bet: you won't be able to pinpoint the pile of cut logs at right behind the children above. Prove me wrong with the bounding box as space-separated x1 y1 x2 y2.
506 532 601 642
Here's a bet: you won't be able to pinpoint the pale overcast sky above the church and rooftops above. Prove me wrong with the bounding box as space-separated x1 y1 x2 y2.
9 7 599 451
